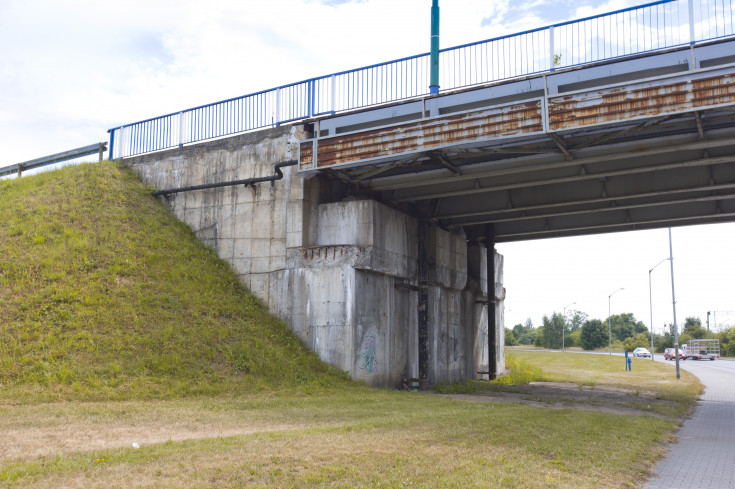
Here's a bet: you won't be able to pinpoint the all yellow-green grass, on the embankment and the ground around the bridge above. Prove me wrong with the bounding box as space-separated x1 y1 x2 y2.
0 164 695 488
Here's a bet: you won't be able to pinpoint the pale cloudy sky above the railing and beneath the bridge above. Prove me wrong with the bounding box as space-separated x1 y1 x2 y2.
0 0 735 328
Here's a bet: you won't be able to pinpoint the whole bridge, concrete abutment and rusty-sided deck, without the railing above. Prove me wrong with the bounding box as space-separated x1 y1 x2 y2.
125 36 735 387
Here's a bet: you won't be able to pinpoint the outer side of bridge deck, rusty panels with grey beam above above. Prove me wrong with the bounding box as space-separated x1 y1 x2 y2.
299 42 735 172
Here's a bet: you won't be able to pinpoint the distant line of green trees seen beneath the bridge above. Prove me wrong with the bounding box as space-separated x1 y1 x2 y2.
505 311 735 357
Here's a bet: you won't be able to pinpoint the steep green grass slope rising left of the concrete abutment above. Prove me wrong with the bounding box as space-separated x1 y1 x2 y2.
0 163 348 402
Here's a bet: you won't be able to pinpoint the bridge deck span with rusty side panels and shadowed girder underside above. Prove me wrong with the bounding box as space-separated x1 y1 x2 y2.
300 40 735 242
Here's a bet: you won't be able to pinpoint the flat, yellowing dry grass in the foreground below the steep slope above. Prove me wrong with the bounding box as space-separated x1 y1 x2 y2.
0 389 675 488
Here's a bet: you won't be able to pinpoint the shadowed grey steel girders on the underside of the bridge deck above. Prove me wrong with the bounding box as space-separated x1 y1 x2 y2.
328 109 735 242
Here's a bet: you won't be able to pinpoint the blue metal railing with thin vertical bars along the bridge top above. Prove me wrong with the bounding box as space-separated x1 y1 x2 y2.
108 0 735 158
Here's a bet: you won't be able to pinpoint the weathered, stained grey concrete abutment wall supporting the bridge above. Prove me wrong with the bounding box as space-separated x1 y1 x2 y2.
125 126 504 386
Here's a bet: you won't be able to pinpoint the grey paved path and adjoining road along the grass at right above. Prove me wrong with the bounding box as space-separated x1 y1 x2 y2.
643 360 735 489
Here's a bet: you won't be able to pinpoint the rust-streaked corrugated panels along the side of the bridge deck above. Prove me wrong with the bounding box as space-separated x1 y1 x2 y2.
299 75 735 168
